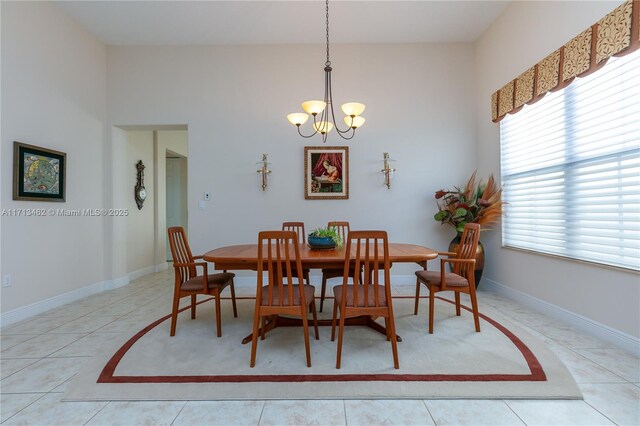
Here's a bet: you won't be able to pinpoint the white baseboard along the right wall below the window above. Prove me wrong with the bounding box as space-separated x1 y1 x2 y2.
482 277 640 356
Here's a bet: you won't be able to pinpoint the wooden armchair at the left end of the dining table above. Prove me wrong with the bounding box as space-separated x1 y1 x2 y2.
168 226 238 337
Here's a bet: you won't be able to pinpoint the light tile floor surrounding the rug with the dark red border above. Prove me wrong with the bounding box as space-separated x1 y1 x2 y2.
0 270 640 425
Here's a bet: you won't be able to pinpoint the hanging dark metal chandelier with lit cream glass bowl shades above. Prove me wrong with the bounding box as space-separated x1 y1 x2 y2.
287 0 365 142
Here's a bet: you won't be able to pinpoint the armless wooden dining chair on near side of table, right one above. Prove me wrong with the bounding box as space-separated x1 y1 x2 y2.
331 231 400 369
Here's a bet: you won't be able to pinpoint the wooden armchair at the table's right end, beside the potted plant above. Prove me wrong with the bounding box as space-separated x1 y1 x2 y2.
413 223 480 334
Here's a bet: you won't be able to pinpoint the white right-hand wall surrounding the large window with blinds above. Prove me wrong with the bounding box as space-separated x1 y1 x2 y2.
475 1 640 338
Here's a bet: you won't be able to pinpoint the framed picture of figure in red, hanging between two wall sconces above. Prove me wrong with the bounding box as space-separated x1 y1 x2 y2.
304 146 349 200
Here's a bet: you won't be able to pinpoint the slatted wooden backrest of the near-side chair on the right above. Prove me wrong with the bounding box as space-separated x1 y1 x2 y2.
342 231 391 308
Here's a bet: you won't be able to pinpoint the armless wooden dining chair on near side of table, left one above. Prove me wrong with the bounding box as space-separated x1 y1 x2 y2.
250 231 319 367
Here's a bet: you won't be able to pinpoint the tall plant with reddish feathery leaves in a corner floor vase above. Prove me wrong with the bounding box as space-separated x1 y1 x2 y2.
433 172 505 287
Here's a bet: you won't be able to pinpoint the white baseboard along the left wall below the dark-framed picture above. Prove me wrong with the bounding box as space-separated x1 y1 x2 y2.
0 277 129 328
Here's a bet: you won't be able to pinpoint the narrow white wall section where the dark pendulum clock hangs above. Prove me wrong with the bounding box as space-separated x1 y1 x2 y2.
121 131 156 273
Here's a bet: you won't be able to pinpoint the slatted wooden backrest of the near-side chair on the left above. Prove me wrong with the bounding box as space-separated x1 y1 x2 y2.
256 231 306 306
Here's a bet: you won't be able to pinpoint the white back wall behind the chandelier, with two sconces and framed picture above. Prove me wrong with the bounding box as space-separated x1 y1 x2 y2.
108 44 476 274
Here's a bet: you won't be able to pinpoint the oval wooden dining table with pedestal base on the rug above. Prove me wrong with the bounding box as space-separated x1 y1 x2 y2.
202 243 438 343
